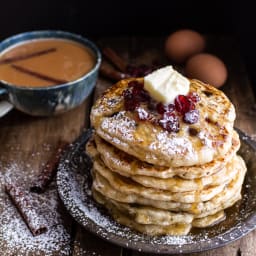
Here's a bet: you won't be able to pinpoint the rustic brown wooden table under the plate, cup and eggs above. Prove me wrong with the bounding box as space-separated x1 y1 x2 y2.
0 37 256 256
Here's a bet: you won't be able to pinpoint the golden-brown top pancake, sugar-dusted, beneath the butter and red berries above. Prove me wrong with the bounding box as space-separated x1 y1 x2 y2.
91 78 235 167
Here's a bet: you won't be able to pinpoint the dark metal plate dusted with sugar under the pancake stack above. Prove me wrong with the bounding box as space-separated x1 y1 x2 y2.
57 130 256 254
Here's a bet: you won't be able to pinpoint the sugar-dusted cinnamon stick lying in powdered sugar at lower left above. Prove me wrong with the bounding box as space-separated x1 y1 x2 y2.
5 180 47 236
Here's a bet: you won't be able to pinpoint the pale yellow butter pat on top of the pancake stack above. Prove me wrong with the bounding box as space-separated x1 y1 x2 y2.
144 66 190 104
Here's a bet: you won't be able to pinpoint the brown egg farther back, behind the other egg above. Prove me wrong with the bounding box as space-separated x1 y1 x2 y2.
165 29 205 63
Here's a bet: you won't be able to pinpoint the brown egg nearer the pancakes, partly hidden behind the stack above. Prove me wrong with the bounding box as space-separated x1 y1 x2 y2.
185 53 228 88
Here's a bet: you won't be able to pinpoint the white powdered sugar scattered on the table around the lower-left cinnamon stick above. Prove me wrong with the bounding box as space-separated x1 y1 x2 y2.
0 150 71 256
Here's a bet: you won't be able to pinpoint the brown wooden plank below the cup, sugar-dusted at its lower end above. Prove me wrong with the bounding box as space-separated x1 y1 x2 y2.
0 101 85 256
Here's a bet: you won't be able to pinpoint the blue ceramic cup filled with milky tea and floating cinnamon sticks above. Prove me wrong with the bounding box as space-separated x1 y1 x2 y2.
0 30 101 116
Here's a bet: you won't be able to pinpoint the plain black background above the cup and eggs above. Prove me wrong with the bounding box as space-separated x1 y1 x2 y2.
0 0 256 87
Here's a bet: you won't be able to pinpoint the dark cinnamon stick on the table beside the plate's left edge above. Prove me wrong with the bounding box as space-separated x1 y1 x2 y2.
30 141 68 193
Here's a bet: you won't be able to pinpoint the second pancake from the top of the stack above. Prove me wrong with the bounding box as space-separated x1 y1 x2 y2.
91 131 240 179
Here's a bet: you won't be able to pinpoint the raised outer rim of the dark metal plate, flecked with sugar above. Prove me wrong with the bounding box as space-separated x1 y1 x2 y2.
56 128 256 254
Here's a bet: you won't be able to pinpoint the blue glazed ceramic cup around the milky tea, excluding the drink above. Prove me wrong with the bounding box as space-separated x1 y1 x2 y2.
0 30 101 116
